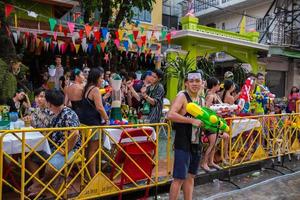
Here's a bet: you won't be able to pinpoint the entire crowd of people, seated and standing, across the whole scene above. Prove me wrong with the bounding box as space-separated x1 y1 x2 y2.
1 53 300 199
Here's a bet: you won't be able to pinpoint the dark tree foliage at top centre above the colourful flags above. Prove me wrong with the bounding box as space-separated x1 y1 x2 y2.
79 0 155 28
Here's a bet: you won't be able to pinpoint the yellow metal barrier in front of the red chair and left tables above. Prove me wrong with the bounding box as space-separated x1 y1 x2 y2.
0 123 171 199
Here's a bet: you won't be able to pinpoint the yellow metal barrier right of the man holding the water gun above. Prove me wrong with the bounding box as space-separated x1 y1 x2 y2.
221 113 300 167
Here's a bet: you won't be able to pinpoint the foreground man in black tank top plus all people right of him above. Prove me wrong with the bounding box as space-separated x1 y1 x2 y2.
167 71 300 200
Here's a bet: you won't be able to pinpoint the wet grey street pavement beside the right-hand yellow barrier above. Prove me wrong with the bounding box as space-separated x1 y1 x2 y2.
151 156 300 200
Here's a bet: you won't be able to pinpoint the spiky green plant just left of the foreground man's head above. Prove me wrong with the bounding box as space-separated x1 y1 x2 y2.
164 52 196 91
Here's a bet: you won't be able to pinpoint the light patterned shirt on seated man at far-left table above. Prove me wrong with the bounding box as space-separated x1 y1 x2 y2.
31 108 54 128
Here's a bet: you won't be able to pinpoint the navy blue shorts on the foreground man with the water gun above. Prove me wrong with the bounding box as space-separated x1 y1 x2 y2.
173 149 201 179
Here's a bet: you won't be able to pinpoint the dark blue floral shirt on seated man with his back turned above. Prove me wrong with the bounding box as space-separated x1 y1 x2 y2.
50 107 81 150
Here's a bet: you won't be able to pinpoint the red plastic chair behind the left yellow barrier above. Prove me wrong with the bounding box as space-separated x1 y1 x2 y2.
111 128 156 199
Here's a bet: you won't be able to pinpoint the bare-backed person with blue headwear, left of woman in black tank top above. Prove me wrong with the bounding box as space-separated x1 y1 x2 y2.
64 68 85 112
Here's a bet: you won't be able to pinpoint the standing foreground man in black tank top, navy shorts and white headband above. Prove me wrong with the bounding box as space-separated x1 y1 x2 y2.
167 72 204 200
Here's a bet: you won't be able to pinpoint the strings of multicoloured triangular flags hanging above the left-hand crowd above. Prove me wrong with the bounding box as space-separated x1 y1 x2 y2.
1 4 176 60
